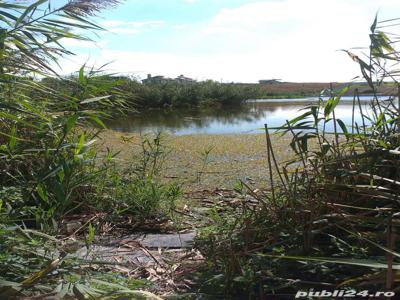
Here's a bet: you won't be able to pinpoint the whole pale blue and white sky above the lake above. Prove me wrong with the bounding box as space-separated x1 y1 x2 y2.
57 0 400 82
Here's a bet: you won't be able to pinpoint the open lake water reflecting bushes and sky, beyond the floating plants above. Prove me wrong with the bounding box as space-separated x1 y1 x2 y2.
107 96 382 135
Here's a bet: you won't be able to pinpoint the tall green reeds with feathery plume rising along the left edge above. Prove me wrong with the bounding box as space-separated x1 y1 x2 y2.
0 1 128 228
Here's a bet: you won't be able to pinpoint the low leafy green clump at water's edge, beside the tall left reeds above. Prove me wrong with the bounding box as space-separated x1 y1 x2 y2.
95 133 181 223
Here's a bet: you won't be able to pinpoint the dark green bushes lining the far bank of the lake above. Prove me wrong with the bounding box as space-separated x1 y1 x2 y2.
42 76 262 109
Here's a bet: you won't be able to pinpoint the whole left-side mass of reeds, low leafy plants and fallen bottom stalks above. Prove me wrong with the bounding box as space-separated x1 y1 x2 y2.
0 0 180 299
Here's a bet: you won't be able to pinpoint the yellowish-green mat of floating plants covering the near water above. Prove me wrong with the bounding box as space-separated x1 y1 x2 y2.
99 132 294 191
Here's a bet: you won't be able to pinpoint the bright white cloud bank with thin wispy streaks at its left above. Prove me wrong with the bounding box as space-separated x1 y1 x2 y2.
57 0 400 82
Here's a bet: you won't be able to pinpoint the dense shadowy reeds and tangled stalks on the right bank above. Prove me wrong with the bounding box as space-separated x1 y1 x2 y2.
195 15 400 299
